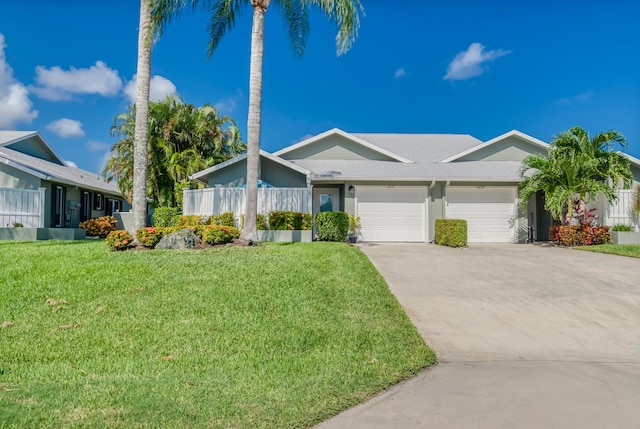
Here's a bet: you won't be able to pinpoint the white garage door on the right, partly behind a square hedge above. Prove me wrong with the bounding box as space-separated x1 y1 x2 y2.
445 186 517 243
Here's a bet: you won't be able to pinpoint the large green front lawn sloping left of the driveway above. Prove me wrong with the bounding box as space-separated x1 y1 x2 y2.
0 241 435 428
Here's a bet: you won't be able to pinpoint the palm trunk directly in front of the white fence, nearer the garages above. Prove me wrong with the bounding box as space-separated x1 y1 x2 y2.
240 0 269 244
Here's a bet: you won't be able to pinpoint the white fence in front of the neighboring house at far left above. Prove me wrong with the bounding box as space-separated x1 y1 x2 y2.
0 188 45 228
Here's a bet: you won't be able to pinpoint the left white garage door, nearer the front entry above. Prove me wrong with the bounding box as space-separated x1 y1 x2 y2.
356 186 427 241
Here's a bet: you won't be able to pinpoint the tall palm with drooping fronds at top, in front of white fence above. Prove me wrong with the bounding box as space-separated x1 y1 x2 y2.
154 0 363 244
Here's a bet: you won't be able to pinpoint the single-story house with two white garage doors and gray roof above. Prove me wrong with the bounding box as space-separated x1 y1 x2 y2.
184 129 640 243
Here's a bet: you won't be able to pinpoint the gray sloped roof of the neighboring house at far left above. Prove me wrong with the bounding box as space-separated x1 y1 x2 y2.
0 145 120 196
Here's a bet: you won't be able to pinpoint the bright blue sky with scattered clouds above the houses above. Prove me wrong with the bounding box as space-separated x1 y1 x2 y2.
0 0 640 171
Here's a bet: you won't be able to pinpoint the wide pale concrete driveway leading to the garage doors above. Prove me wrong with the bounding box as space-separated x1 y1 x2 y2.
318 244 640 429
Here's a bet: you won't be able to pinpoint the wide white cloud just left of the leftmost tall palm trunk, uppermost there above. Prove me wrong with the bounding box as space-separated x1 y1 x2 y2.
29 61 122 101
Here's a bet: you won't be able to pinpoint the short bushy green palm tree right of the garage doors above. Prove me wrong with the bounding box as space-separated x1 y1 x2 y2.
520 127 633 225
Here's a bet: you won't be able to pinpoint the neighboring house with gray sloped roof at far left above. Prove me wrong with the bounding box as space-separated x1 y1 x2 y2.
0 131 129 228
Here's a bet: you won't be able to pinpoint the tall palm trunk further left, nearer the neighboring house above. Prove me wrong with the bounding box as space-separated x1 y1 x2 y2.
131 0 152 231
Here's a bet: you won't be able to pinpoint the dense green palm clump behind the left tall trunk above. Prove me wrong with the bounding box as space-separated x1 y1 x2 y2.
103 96 246 207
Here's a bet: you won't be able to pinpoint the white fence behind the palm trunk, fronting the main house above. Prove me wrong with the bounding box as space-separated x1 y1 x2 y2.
182 186 311 217
